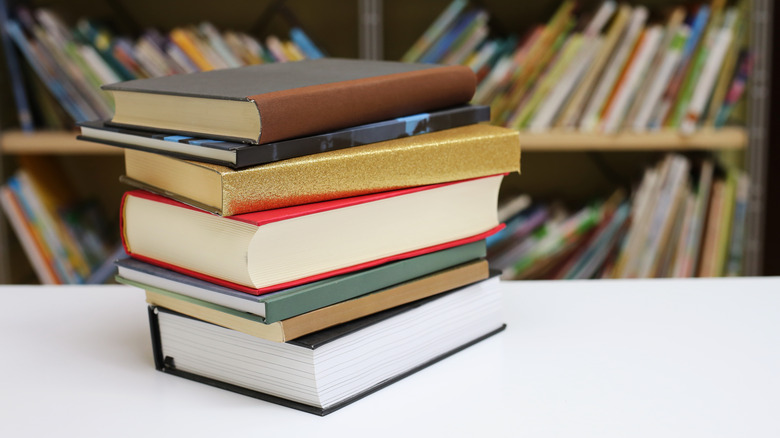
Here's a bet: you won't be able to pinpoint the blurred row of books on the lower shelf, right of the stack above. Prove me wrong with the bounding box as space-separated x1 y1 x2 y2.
488 155 749 279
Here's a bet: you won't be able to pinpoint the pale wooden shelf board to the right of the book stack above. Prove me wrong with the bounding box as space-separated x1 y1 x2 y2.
520 127 747 152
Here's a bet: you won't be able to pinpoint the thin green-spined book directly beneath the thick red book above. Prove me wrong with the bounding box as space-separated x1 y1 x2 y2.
116 241 485 323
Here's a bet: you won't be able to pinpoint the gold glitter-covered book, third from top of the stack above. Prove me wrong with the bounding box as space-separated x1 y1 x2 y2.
122 124 520 216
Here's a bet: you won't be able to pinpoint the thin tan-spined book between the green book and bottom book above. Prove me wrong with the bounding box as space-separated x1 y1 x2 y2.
137 260 489 342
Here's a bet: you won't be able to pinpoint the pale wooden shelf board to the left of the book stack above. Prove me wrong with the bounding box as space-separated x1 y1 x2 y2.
0 130 122 155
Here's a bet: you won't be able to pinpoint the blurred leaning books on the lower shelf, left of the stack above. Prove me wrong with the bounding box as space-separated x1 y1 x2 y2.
0 156 123 284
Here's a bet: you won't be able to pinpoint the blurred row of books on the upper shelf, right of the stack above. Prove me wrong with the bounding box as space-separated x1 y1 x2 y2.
403 0 752 133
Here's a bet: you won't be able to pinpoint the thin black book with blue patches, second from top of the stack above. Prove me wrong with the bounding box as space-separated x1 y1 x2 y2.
78 105 490 169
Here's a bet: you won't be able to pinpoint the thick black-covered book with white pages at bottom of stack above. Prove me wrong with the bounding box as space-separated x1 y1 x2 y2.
149 274 505 415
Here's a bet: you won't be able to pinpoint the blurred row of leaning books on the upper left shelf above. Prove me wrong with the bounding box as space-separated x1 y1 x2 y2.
3 8 324 130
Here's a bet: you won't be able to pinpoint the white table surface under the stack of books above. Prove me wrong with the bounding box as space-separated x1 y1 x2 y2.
0 278 780 438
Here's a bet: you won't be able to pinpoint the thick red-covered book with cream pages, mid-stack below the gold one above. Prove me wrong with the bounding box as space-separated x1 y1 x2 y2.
120 175 503 294
